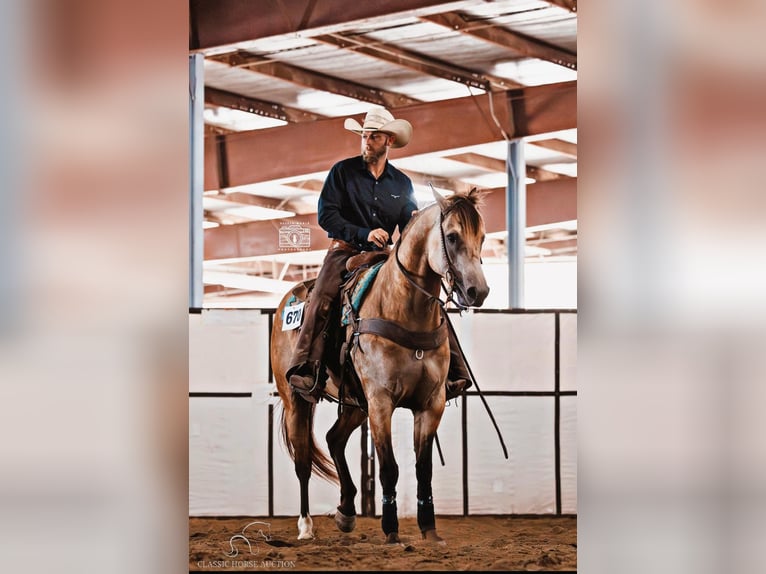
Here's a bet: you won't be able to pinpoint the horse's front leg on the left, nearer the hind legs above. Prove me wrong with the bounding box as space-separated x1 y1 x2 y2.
369 398 401 544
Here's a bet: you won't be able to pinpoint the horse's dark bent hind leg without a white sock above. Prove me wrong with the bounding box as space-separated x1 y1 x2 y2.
327 408 367 532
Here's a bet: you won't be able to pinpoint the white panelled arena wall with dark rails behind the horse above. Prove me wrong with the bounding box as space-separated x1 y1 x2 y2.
189 309 577 516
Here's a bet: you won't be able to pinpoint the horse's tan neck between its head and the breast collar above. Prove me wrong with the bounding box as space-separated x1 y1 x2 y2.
368 209 440 325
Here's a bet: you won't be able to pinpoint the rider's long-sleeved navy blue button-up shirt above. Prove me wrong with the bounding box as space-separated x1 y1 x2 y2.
318 155 418 251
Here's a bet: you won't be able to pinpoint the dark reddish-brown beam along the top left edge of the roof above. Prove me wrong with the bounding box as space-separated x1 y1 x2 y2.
189 0 483 52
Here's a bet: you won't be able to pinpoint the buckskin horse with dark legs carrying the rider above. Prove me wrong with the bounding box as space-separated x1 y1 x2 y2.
270 188 489 544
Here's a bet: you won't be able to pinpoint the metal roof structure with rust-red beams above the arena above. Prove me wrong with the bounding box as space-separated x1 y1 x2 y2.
191 0 577 306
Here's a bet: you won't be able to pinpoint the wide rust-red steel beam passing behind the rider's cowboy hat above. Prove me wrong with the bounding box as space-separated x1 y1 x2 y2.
205 82 577 190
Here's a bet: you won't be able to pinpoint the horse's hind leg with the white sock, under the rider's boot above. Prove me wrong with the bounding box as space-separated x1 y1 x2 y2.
285 399 314 540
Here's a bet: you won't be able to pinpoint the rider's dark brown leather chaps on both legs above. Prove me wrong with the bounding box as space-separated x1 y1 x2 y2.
287 241 471 386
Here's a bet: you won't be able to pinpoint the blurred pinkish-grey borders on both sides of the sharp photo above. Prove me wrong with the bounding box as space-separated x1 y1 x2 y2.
0 0 766 574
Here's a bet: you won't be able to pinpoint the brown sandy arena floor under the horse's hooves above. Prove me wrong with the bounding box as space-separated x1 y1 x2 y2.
189 516 577 572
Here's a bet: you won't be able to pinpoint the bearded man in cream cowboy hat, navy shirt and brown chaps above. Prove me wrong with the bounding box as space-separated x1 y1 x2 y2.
287 106 471 402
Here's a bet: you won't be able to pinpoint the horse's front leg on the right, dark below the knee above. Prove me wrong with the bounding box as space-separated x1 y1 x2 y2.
414 403 444 542
